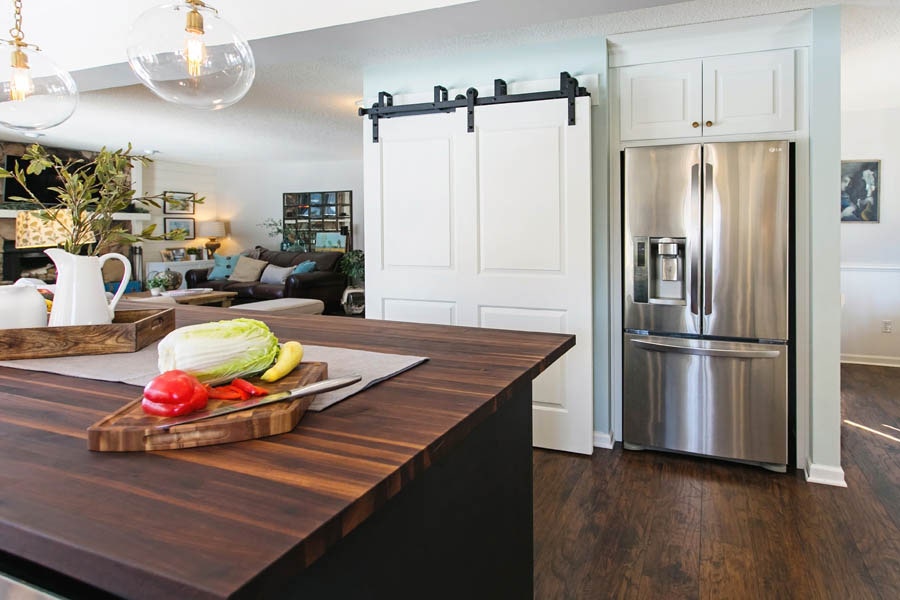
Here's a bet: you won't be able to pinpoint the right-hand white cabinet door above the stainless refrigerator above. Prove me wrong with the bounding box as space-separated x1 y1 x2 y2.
703 50 794 136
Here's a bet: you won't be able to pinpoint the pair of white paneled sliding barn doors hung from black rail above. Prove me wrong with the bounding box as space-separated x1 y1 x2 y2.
364 97 593 454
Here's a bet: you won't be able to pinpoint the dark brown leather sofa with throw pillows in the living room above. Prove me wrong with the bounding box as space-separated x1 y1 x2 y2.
185 246 347 313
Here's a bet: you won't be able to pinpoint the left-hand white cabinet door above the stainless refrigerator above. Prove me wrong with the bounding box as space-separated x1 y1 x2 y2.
618 60 702 140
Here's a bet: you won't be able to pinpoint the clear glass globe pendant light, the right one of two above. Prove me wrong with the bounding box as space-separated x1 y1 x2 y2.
128 0 256 110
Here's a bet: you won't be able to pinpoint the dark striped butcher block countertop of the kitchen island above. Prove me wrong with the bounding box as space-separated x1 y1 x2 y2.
0 306 574 598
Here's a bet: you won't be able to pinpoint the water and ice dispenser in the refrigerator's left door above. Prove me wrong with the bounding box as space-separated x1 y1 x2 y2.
634 237 687 305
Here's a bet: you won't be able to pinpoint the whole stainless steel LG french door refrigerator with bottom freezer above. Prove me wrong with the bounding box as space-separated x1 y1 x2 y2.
622 141 792 470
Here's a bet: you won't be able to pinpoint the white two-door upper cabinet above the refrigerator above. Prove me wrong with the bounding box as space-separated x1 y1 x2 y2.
618 50 795 141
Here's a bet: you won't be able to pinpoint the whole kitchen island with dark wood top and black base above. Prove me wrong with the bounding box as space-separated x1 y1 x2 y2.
0 306 574 598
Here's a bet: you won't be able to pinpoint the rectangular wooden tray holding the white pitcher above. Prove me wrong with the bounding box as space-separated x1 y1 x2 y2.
0 308 175 360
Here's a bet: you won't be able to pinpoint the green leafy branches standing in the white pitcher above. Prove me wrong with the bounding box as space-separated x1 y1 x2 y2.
0 144 203 255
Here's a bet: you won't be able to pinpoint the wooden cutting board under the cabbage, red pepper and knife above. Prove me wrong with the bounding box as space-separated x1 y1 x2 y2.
88 362 328 452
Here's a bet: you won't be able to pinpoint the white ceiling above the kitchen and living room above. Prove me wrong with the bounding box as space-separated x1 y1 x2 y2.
0 0 900 166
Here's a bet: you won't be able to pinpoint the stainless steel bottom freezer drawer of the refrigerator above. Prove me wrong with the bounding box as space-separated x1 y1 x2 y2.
622 334 787 465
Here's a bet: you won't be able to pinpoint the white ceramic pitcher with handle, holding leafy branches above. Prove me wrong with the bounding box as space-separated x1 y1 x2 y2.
44 248 131 327
